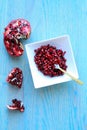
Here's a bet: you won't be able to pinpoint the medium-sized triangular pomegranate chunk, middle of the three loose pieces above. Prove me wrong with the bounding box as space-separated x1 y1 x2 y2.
7 68 23 88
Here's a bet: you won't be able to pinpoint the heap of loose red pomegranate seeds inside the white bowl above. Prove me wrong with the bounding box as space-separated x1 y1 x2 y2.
34 44 67 77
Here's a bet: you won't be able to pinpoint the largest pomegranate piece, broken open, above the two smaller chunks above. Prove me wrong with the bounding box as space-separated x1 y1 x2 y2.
4 19 31 56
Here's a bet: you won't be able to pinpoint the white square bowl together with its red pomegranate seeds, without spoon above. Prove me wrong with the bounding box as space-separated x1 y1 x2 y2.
25 35 78 88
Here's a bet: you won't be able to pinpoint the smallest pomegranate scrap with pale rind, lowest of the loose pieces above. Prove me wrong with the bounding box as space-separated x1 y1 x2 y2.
7 99 25 112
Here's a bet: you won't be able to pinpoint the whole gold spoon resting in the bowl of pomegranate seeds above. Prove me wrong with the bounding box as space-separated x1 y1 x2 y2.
55 64 83 85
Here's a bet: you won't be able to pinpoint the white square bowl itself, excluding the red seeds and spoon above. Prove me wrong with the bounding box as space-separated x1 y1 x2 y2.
25 35 79 88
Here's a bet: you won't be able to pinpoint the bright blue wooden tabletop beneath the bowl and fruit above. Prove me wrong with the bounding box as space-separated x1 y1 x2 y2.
0 0 87 130
